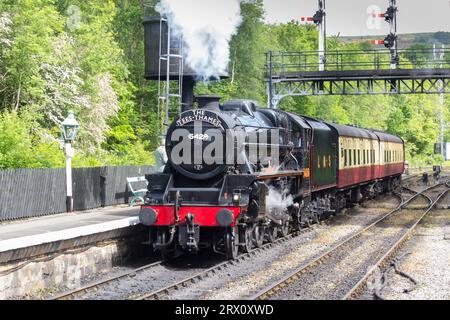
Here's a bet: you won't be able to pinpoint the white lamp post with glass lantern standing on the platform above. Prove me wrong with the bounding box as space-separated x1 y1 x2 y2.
60 111 80 212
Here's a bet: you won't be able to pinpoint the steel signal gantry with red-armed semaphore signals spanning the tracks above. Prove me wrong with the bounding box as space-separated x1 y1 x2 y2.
265 0 450 108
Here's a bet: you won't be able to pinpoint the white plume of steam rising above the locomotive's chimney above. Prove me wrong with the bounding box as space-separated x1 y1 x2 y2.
156 0 242 80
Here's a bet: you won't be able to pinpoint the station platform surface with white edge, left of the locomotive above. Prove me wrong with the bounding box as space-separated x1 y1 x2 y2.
0 205 142 264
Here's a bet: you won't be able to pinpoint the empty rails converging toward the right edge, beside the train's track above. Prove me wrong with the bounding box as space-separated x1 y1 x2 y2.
252 183 450 299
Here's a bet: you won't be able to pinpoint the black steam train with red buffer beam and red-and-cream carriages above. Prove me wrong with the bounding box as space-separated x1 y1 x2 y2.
139 96 405 259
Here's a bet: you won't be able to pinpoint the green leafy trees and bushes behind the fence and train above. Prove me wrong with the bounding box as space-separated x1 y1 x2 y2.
0 0 450 168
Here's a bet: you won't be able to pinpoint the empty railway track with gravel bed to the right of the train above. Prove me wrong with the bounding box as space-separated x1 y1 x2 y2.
250 181 450 300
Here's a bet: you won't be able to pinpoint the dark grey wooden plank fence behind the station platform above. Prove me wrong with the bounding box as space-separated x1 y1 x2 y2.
0 166 154 221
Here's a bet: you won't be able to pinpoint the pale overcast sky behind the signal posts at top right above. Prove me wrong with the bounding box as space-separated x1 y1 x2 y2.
264 0 450 36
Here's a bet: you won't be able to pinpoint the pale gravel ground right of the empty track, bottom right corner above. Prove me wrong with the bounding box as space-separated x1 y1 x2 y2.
361 197 450 300
